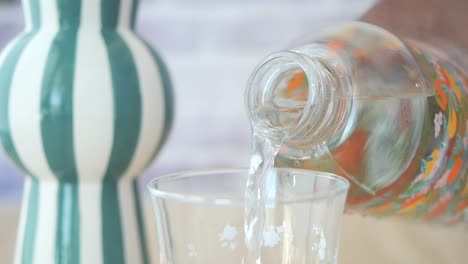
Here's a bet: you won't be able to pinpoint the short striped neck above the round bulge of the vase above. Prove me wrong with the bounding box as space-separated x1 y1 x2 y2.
23 0 138 30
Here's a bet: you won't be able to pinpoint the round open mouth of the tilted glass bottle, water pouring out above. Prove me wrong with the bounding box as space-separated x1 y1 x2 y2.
246 52 322 142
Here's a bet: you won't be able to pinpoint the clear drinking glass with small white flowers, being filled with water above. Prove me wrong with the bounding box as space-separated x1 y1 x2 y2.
148 169 349 264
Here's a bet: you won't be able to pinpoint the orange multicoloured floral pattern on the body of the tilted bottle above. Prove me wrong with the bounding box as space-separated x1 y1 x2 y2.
351 46 468 224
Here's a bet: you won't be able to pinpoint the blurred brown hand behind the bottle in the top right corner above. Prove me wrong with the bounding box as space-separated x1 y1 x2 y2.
361 0 468 51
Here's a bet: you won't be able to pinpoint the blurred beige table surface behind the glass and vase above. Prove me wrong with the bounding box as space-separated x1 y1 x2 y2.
0 205 468 264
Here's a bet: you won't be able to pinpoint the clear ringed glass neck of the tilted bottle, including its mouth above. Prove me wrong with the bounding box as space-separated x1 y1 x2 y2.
246 51 352 152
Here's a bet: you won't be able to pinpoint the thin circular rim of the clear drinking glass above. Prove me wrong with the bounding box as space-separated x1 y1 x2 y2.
146 168 350 207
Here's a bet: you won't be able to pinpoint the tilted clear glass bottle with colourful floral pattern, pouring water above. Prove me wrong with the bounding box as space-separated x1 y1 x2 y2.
246 22 468 224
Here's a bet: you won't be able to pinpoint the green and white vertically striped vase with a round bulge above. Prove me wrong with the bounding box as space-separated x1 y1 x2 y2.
0 0 173 264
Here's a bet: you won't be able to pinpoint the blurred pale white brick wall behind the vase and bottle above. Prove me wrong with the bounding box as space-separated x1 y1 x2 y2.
0 0 376 202
